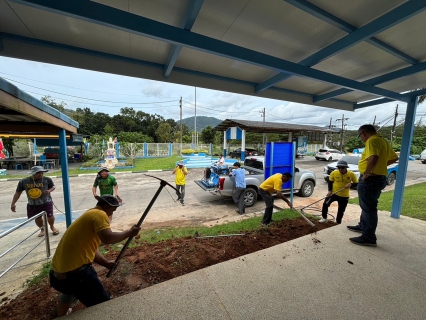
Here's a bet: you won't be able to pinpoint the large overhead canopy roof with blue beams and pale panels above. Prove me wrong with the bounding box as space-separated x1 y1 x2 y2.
0 0 426 112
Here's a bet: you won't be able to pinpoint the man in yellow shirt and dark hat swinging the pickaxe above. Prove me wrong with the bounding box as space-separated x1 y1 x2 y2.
49 195 140 317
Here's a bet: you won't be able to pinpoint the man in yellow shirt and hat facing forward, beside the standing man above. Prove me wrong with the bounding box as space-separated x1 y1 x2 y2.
319 160 358 224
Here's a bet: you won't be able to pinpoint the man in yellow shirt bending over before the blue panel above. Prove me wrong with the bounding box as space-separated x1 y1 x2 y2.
259 172 293 227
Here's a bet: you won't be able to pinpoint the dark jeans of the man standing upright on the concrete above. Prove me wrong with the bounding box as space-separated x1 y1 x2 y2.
358 176 386 241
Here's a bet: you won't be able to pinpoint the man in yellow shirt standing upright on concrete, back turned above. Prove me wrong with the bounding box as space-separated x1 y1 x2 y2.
348 124 398 247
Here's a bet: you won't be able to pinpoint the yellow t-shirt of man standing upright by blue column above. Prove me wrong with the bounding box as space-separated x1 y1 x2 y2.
358 134 398 176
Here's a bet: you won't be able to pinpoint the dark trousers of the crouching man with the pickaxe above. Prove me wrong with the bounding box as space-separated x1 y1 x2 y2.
49 266 110 307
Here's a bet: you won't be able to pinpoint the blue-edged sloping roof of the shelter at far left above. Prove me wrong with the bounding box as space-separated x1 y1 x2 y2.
0 78 79 138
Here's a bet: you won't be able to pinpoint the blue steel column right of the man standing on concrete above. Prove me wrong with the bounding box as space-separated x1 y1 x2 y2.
391 97 417 219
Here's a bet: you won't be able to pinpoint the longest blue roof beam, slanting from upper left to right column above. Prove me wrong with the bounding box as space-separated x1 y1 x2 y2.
13 0 410 102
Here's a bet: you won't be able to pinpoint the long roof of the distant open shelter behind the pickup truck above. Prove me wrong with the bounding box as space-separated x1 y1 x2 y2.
213 119 335 133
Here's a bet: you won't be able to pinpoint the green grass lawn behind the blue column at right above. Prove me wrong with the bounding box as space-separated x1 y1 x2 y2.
349 182 426 221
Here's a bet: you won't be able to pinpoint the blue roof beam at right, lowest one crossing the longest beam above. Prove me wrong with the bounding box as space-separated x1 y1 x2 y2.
313 62 426 102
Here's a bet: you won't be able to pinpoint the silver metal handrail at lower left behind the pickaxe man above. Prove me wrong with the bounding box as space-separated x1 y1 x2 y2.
0 211 50 278
